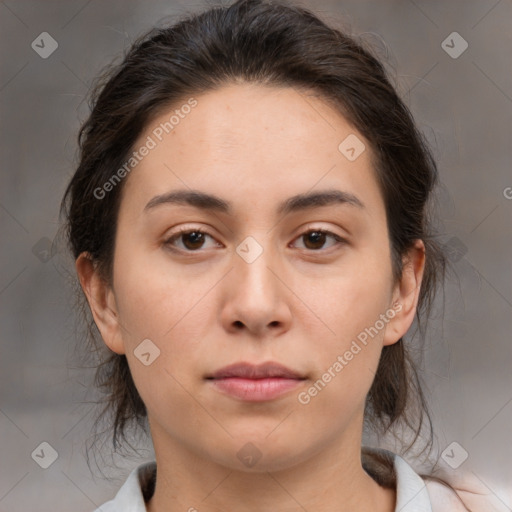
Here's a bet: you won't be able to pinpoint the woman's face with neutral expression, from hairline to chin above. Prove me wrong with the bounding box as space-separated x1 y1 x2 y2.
87 84 420 470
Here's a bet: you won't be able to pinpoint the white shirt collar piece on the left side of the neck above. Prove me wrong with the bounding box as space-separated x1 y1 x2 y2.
94 461 156 512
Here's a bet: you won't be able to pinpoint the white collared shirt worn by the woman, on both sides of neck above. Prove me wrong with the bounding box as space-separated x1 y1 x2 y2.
95 449 466 512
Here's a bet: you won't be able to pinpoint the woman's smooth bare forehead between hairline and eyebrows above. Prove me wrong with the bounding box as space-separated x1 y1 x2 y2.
123 84 382 219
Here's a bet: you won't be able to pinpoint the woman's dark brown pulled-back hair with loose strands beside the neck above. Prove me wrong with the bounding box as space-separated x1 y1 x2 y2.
61 0 468 504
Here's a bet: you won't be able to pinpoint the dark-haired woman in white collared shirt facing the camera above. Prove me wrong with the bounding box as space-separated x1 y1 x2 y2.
63 0 480 512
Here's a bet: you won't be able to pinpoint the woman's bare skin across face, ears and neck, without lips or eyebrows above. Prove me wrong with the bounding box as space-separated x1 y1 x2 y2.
76 84 425 512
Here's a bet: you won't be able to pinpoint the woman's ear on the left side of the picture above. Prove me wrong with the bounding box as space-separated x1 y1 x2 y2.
75 252 125 354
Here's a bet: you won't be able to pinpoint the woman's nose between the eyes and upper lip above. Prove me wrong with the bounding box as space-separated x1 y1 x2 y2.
221 239 293 338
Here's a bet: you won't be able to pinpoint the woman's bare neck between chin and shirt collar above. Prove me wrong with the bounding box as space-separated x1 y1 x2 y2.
147 420 396 512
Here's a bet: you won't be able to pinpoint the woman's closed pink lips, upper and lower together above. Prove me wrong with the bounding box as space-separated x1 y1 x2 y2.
206 362 306 402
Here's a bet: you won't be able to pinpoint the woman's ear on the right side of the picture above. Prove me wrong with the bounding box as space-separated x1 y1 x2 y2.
383 239 425 345
